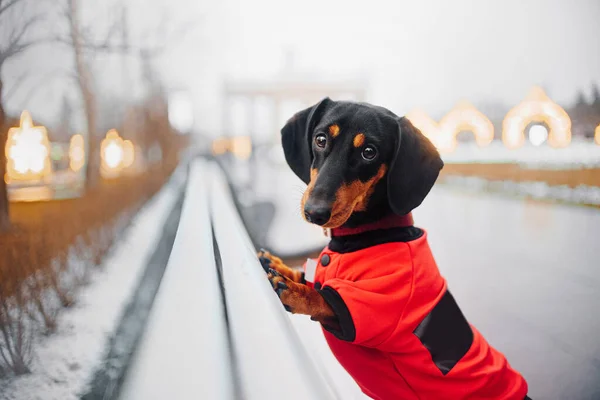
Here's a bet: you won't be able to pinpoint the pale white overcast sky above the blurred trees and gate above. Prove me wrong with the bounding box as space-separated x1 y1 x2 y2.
4 0 600 139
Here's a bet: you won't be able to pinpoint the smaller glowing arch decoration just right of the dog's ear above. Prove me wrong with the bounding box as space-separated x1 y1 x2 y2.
439 101 494 151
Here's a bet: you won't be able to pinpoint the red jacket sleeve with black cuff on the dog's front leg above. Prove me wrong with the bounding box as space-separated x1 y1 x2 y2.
320 271 413 347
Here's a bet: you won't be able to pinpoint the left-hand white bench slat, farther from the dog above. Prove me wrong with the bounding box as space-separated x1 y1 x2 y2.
121 161 234 400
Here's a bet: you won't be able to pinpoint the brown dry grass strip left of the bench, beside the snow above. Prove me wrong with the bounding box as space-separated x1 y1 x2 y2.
0 163 175 377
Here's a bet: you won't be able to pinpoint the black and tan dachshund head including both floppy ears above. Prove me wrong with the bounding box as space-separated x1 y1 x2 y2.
281 98 444 228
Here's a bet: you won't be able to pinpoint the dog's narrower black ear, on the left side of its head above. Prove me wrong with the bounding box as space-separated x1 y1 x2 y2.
281 97 331 184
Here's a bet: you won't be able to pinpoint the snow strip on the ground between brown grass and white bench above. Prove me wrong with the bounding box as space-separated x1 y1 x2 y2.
0 167 185 400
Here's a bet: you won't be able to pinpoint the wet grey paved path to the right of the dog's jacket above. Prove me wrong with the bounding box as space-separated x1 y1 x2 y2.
415 188 600 400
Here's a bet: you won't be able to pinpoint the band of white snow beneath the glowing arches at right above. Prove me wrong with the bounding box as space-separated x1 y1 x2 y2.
442 139 600 169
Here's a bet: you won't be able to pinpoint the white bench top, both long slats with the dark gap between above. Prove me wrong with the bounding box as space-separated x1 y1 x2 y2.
121 159 338 400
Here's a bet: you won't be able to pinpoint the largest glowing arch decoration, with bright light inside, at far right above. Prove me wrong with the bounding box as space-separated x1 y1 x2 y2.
502 87 571 149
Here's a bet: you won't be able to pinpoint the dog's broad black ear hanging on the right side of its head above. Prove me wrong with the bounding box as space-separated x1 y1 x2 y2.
387 117 444 215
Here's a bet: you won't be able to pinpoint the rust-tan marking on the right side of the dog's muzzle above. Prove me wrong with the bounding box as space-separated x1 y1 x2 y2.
323 164 387 228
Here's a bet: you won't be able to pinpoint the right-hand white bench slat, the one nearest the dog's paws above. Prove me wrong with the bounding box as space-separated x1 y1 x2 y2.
207 164 336 400
